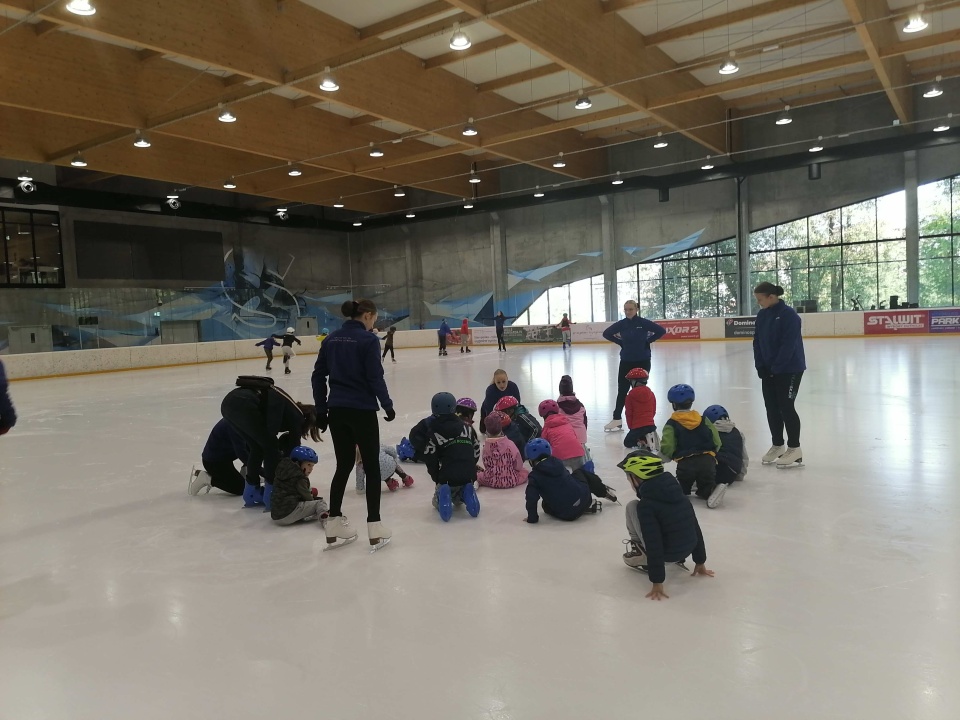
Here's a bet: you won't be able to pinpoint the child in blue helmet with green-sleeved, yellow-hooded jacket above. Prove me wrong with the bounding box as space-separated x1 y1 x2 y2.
660 385 727 508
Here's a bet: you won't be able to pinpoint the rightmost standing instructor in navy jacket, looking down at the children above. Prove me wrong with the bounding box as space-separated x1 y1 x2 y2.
753 282 807 464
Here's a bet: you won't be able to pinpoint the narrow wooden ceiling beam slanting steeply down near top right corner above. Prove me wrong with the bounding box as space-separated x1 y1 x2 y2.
843 0 913 124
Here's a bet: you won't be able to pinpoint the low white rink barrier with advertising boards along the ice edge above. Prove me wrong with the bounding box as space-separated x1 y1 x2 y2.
0 308 960 380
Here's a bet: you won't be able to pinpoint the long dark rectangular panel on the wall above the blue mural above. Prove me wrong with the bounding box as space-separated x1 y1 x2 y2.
73 221 224 281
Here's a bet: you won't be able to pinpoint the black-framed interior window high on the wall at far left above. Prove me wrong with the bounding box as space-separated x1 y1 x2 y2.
0 209 63 287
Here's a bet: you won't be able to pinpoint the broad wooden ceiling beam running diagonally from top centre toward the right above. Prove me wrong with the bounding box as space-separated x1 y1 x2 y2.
448 0 726 153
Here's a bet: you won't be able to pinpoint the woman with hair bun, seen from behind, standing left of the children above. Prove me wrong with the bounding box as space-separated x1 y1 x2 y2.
312 300 396 552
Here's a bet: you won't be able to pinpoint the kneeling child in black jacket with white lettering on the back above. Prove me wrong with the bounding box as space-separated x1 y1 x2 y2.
424 392 480 522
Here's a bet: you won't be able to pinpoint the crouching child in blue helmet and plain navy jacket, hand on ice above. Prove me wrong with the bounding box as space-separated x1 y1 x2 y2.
523 438 601 523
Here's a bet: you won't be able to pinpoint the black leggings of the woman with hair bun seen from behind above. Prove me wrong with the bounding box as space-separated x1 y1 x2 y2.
330 408 381 522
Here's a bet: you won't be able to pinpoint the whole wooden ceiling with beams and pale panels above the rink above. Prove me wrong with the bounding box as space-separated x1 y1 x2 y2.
0 0 960 215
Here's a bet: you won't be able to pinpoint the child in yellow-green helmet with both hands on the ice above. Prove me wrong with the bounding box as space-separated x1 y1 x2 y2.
617 450 713 600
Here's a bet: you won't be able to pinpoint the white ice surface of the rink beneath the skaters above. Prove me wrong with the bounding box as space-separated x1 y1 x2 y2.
0 338 960 720
